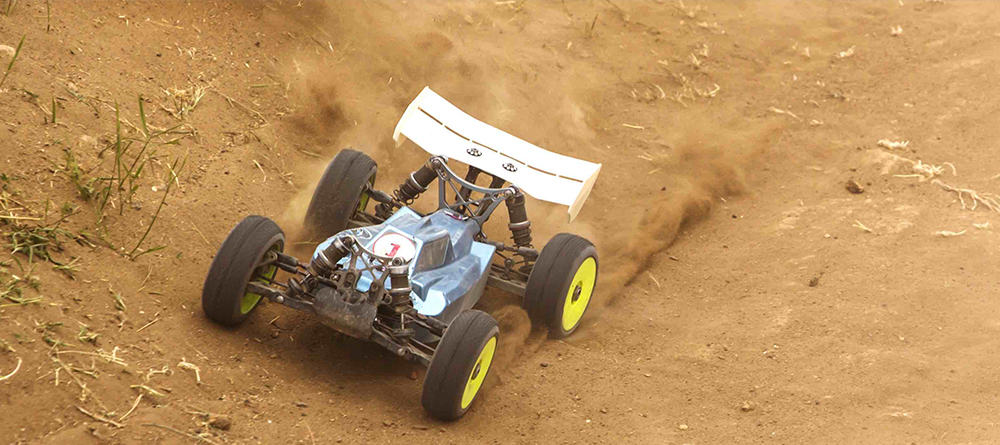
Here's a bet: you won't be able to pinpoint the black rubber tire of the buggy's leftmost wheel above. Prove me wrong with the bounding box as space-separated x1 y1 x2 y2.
201 215 285 326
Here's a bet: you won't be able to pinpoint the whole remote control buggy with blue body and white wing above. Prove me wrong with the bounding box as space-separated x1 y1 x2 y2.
202 88 601 420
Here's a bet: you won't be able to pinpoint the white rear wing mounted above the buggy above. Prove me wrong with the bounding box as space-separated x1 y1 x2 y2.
392 87 601 221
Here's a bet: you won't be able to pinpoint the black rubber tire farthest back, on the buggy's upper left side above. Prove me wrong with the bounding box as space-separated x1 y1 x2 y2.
304 149 378 239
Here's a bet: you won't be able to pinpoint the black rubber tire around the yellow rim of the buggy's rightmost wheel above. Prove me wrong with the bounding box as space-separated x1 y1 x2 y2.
522 233 599 338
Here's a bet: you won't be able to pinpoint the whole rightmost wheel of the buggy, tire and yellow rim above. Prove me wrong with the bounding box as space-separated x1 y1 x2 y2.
523 233 597 338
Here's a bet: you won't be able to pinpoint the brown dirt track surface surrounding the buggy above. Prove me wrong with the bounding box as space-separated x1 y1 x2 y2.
0 0 1000 444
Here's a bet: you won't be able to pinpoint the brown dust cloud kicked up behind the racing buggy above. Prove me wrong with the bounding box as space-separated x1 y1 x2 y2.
270 3 778 363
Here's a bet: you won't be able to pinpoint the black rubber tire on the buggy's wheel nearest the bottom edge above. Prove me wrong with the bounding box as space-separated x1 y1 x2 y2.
420 310 500 421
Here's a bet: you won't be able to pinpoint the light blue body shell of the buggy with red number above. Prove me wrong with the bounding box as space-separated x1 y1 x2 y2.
313 207 496 322
